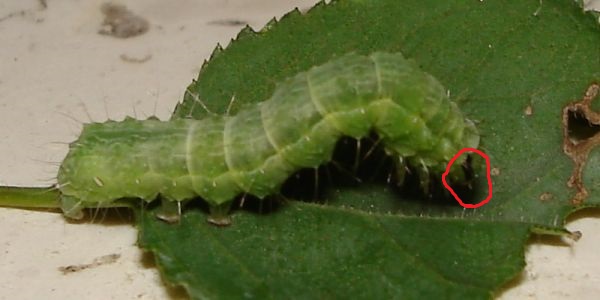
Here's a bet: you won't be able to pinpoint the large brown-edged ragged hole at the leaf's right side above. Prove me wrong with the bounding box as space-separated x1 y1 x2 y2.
562 83 600 205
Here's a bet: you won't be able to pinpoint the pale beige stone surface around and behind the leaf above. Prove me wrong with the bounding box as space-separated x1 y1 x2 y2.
0 0 600 299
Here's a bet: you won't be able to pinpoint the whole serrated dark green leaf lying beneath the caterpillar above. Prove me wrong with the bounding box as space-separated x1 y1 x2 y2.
139 0 600 298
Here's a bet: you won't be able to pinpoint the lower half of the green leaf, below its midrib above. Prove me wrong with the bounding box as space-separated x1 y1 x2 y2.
139 203 529 299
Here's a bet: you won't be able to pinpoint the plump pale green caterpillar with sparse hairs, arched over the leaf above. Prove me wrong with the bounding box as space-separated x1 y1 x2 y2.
58 52 479 222
